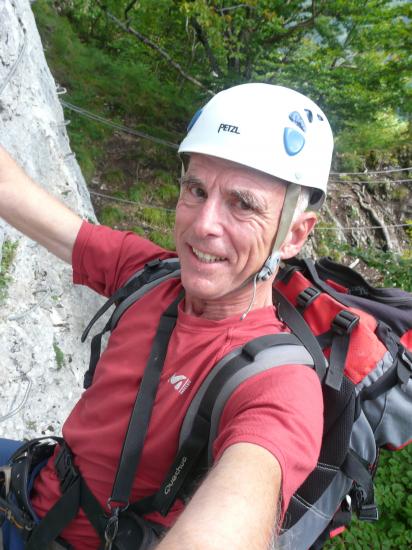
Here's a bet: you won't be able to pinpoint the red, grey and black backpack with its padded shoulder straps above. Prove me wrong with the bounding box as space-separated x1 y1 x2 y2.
75 258 412 549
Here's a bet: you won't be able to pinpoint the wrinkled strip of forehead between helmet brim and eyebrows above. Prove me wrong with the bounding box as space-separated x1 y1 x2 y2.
185 153 287 193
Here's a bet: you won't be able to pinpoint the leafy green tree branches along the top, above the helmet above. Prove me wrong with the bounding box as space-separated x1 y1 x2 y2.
63 0 412 145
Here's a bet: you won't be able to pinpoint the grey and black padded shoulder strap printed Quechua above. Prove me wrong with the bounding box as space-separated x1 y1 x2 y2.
132 333 314 515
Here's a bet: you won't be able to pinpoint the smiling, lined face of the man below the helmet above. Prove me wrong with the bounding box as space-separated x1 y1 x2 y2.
175 154 286 300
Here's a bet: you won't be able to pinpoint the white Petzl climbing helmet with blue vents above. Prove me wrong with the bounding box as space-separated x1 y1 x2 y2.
179 83 333 209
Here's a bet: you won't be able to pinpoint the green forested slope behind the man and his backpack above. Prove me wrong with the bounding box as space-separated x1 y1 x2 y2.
28 0 412 550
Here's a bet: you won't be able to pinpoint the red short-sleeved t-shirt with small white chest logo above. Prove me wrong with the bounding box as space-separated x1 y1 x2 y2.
32 222 323 550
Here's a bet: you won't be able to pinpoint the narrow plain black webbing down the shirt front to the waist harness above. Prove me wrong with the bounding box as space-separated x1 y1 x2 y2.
26 293 183 550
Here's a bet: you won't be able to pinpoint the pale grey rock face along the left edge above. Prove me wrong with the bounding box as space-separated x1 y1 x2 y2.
0 0 100 439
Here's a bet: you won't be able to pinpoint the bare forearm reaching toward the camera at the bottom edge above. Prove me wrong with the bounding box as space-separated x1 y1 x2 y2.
156 443 281 550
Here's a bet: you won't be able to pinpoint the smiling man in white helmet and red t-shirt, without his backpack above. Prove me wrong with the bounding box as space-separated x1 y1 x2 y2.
0 84 333 550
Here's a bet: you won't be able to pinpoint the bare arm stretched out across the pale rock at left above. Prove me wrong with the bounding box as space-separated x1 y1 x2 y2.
0 146 82 263
